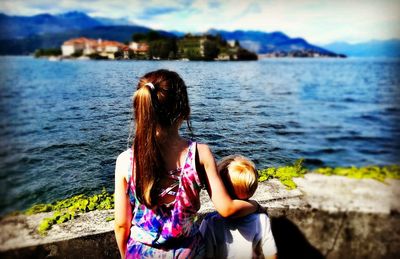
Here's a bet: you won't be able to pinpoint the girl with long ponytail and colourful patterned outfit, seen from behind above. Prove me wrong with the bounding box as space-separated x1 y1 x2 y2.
114 70 258 258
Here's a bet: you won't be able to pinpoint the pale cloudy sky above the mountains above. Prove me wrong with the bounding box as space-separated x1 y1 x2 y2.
0 0 400 44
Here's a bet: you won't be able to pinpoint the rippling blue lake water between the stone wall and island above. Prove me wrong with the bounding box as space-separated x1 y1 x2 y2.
0 57 400 214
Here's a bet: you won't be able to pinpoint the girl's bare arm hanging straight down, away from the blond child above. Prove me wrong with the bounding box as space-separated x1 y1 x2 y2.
114 152 132 258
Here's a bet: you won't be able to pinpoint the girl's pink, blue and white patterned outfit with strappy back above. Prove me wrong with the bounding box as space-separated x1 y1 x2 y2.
126 142 205 258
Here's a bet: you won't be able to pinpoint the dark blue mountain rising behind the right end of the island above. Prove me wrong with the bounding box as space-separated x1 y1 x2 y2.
207 29 341 55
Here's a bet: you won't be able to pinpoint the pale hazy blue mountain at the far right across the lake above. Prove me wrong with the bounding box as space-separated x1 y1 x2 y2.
324 39 400 57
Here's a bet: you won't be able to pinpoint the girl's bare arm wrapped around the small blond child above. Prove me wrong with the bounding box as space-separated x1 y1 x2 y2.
197 144 258 217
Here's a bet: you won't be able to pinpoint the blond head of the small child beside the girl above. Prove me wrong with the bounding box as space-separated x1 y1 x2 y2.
218 155 258 200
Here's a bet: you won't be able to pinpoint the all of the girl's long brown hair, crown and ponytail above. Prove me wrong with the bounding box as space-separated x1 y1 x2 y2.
132 69 190 208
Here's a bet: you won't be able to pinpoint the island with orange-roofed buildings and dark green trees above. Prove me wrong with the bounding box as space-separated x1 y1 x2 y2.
35 31 258 61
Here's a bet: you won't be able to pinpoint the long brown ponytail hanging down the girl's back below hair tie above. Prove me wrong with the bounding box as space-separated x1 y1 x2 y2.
132 86 163 208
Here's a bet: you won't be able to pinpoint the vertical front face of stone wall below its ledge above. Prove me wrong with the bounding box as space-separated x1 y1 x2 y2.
0 209 400 259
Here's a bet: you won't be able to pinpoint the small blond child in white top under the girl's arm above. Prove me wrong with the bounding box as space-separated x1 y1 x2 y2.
200 156 277 258
